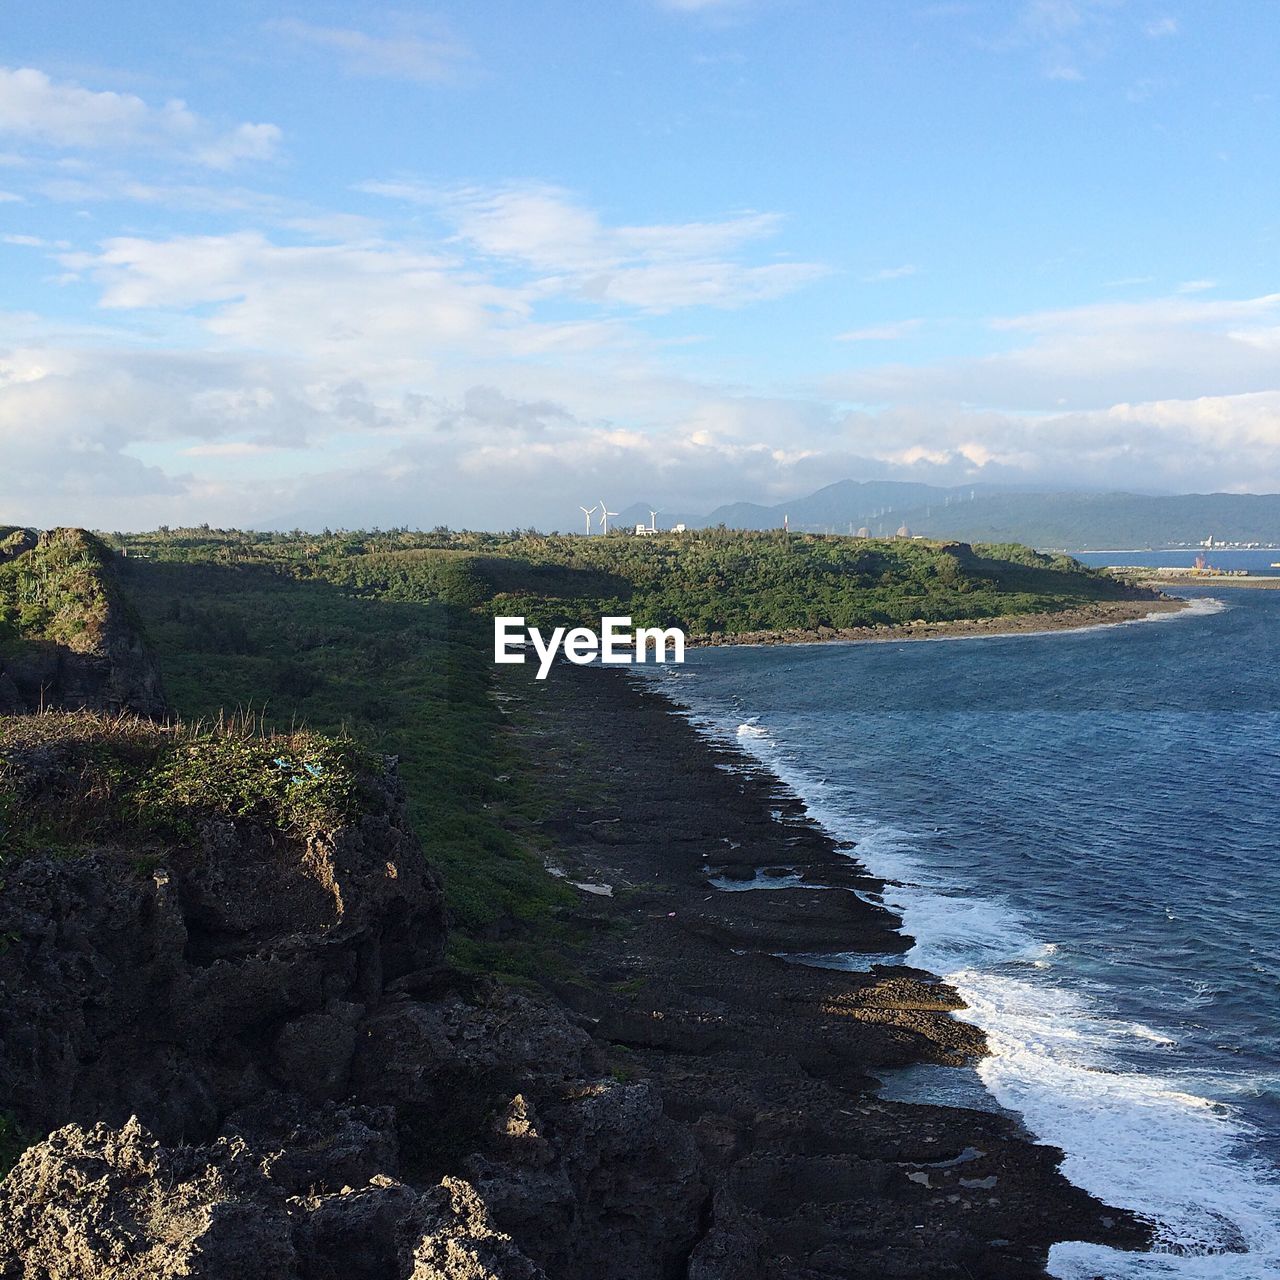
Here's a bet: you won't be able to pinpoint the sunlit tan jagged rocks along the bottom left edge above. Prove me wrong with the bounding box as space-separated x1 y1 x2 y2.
0 1119 545 1280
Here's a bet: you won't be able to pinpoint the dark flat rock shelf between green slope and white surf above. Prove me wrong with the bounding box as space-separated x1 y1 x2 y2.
504 664 1147 1280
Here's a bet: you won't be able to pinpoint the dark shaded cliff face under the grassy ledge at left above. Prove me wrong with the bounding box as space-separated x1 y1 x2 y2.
0 774 444 1140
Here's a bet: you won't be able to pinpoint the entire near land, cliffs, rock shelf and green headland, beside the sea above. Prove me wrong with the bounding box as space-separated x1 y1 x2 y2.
0 530 1158 1280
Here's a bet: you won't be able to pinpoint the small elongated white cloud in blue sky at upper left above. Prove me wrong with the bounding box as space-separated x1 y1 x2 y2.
0 67 280 169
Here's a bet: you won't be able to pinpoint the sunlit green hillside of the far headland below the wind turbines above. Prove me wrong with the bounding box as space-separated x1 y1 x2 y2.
110 529 1152 635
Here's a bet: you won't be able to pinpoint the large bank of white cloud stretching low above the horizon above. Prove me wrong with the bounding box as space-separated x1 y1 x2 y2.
10 160 1280 527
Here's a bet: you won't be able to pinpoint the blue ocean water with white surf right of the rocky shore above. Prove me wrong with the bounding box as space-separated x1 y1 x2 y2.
655 590 1280 1280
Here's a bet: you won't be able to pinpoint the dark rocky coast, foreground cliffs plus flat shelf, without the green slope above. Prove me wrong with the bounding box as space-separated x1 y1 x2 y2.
0 535 1148 1280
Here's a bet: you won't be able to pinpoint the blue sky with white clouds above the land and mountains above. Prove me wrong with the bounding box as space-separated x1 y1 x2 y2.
0 0 1280 530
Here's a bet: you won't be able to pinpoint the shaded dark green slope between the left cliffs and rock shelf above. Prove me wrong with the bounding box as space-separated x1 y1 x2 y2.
119 555 573 977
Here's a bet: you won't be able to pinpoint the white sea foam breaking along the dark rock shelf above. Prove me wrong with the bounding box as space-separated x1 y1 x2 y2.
670 686 1280 1280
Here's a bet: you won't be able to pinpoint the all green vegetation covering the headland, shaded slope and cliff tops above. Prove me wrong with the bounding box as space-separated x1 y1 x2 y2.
0 519 1126 978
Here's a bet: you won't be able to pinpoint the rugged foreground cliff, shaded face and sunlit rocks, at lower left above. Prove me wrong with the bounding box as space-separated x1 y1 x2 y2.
0 730 709 1280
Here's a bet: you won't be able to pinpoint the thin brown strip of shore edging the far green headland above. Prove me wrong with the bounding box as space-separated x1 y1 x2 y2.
686 593 1190 649
